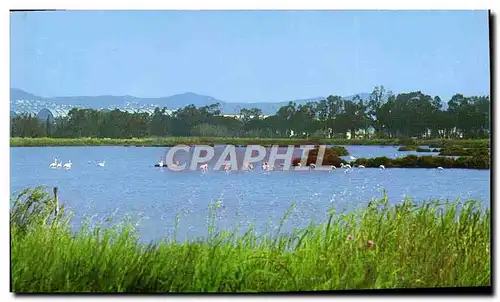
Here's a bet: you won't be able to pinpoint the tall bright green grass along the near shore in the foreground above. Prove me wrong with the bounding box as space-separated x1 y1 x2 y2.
10 190 491 292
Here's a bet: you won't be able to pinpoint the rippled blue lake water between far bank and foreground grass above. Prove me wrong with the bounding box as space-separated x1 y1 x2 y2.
10 146 490 242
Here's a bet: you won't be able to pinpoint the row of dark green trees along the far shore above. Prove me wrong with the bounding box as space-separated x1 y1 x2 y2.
11 86 490 138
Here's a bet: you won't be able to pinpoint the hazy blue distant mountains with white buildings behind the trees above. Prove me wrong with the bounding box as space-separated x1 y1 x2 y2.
10 88 370 115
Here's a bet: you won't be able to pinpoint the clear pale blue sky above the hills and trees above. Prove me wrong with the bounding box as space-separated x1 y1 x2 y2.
10 11 490 102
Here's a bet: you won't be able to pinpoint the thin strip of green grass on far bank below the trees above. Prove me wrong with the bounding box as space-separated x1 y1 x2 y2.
10 137 489 148
